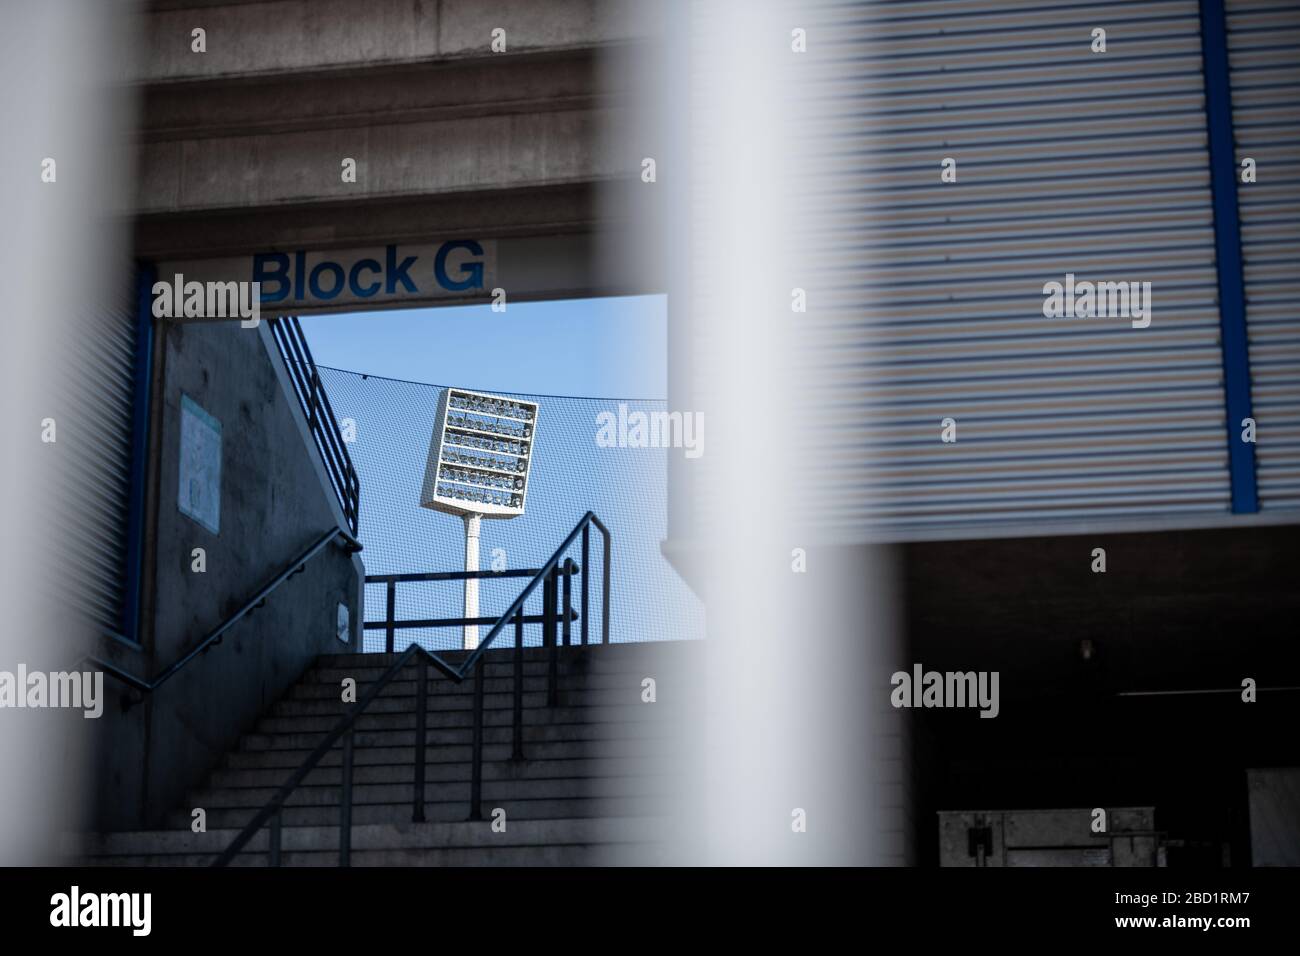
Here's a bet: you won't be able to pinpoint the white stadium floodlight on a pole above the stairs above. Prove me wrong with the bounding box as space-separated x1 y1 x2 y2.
420 389 537 650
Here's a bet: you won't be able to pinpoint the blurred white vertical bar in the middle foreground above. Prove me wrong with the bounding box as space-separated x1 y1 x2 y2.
611 0 904 865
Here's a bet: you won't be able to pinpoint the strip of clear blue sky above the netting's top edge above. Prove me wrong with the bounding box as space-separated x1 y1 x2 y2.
302 295 667 399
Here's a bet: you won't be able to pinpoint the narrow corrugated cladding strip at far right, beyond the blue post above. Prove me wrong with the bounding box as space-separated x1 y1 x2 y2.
1226 0 1300 511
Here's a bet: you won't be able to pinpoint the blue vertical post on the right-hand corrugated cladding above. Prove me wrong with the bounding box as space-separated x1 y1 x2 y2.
1201 0 1260 514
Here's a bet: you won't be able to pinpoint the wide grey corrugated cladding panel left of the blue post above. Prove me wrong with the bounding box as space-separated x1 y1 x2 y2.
807 0 1230 537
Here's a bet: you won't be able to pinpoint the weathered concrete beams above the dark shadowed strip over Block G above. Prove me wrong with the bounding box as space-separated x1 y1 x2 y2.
135 0 641 216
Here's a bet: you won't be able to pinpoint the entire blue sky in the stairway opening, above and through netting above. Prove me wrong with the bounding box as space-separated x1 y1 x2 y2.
302 295 703 650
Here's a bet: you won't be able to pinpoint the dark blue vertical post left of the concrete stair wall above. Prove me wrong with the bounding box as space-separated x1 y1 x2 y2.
122 263 157 643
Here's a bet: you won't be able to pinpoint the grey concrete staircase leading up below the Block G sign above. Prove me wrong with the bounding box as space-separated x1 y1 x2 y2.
72 641 702 866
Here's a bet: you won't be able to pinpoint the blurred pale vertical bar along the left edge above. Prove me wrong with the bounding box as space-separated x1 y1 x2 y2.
0 0 134 865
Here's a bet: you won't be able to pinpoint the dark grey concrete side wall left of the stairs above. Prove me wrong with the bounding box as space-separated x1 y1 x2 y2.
92 323 364 829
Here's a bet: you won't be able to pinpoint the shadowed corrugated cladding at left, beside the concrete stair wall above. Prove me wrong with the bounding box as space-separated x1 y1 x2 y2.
59 269 137 632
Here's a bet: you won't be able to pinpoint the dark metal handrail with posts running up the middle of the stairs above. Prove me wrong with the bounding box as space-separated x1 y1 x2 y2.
212 511 610 866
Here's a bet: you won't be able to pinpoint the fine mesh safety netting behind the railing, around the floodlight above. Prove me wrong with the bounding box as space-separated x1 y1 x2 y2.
320 367 705 652
